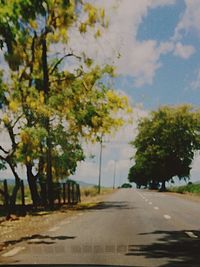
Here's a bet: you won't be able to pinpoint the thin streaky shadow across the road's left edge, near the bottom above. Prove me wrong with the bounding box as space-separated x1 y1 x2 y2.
4 234 76 246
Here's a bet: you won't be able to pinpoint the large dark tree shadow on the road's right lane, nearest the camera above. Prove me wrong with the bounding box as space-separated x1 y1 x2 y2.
126 230 200 267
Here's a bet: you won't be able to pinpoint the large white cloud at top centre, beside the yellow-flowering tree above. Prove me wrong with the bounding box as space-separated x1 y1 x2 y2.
64 0 184 87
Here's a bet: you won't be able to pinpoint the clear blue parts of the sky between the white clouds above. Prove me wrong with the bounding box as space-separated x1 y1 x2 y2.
115 0 200 109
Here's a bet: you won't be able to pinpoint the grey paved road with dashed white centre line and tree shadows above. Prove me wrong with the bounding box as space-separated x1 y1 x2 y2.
1 189 200 267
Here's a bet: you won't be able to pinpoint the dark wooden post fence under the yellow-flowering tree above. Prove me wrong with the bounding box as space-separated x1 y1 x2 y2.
0 180 81 214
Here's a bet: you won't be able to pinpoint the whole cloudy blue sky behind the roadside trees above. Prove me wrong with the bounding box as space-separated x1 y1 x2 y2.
2 0 200 186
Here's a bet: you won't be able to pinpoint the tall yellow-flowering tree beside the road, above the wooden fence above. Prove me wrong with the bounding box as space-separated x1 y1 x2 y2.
0 0 131 205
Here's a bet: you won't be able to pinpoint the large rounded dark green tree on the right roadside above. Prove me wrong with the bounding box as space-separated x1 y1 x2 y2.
129 105 200 190
